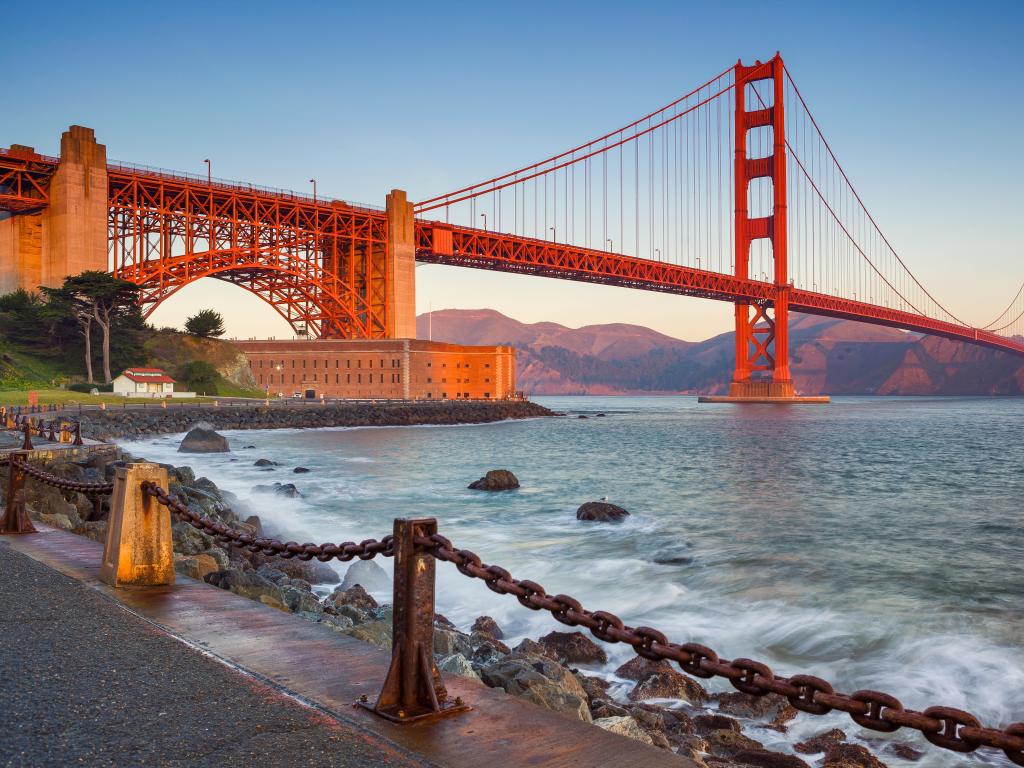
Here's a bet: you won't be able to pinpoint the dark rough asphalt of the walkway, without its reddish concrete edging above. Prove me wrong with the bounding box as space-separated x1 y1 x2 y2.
0 547 427 768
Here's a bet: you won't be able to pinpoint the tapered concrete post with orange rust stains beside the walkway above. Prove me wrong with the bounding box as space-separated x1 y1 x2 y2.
99 464 174 587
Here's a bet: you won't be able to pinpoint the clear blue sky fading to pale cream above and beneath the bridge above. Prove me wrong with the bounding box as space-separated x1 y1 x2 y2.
0 2 1024 339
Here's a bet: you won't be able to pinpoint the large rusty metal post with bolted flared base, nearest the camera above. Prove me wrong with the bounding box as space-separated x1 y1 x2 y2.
359 517 469 723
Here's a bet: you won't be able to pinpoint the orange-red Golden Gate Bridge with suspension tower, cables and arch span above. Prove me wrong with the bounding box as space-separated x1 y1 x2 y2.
0 54 1024 397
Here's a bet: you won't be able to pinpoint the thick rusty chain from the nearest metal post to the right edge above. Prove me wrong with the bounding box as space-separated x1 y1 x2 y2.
416 534 1024 766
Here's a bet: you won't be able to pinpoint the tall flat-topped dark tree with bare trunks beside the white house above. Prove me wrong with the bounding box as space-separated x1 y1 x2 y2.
40 270 138 384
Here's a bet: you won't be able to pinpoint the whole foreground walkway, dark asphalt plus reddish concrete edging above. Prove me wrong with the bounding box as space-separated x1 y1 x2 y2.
0 523 695 768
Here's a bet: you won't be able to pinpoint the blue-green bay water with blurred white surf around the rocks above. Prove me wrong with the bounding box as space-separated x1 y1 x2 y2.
127 397 1024 767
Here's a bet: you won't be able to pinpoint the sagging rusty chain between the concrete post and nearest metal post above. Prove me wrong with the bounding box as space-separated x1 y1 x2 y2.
142 480 394 562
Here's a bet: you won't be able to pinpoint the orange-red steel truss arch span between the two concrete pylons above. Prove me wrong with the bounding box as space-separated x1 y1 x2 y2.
109 170 387 338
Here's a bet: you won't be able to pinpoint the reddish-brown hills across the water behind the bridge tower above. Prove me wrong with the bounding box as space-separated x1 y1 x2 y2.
417 309 1024 395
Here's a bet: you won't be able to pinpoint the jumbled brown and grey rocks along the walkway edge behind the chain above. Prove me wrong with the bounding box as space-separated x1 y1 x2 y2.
0 444 922 768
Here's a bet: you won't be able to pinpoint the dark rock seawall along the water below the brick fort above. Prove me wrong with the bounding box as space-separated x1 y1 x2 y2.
79 400 553 441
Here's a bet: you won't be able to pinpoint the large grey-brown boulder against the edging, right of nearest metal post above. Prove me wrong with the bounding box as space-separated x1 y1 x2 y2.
480 656 591 723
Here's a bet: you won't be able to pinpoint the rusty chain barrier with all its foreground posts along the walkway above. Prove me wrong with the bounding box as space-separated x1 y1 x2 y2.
0 452 1024 766
